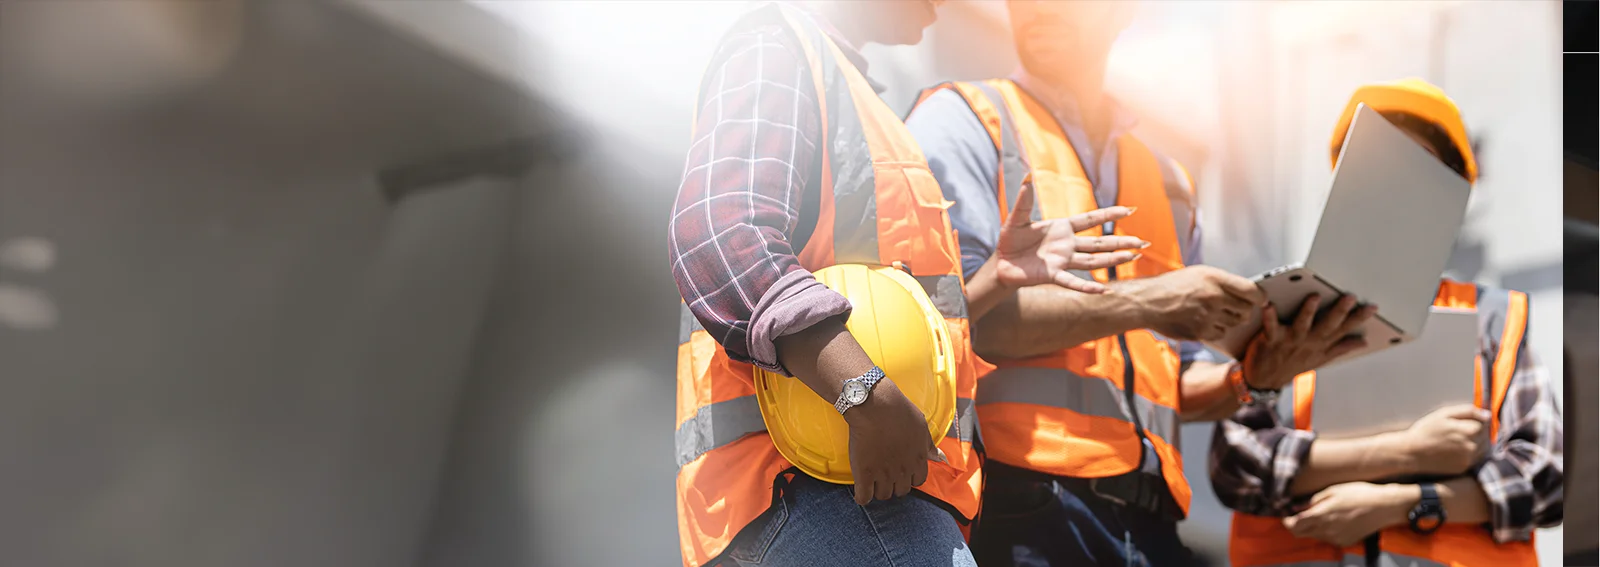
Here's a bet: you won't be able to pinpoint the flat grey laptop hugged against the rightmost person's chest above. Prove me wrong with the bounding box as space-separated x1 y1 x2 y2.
1310 308 1478 439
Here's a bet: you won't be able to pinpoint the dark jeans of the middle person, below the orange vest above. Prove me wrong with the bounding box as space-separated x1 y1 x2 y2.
973 461 1195 567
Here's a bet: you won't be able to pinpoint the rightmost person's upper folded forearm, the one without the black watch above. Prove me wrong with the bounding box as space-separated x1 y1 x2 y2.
1290 432 1410 497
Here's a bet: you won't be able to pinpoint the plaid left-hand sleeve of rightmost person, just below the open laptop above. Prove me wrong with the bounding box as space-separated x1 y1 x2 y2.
1208 400 1317 517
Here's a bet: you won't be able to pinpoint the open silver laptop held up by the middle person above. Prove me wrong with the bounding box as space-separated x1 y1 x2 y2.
1211 104 1470 359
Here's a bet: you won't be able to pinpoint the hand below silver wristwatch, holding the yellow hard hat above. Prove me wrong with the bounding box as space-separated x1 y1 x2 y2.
845 378 944 506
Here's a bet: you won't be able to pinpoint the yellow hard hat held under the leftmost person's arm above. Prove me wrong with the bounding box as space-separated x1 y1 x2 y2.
755 264 955 484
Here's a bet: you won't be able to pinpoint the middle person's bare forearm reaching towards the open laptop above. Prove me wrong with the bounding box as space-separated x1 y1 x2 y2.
968 280 1149 359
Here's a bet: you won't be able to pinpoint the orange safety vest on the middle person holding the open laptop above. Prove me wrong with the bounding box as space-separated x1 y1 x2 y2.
918 80 1192 516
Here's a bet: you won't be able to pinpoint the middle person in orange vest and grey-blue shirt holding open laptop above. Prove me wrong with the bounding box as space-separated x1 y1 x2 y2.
907 0 1373 567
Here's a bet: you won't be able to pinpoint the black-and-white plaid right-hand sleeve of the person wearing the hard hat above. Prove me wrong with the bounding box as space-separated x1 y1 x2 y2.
1475 340 1565 543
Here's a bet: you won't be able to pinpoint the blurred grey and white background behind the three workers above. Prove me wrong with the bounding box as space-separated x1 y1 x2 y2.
0 0 1563 567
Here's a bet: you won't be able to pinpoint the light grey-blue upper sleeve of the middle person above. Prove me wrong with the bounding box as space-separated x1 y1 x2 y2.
906 90 1000 277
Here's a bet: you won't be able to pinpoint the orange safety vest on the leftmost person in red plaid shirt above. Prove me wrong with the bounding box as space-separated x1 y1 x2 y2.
674 5 982 567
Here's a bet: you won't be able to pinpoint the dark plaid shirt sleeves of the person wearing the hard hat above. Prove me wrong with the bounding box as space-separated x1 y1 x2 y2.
1210 312 1563 543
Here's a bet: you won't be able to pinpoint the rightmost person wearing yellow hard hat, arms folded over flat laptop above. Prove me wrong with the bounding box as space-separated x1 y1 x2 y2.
1210 78 1563 567
